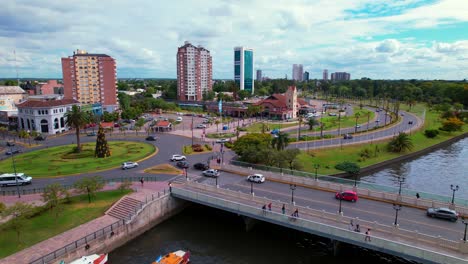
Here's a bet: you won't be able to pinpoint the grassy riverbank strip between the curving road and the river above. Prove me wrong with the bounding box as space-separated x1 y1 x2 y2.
298 105 468 174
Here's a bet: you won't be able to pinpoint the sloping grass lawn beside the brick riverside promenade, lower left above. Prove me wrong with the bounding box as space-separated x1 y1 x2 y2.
0 190 128 258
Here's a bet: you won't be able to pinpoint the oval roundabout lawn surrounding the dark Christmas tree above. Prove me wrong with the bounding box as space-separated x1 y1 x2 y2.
0 141 156 178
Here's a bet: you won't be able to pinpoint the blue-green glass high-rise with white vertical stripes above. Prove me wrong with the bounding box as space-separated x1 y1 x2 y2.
234 47 254 94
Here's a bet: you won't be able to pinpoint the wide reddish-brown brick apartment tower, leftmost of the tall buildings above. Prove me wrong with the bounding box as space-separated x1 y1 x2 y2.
62 50 119 113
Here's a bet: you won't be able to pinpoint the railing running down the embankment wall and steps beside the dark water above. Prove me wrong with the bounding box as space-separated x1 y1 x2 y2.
30 189 169 264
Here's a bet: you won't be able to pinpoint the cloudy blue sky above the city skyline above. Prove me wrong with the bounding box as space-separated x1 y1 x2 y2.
0 0 468 80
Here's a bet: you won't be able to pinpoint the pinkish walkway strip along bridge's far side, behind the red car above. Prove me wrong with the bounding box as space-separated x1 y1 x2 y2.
221 164 468 216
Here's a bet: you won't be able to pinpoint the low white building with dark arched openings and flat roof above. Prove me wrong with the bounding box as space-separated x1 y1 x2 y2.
16 98 80 135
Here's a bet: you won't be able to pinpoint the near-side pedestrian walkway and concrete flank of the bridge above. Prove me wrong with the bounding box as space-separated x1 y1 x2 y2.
172 182 468 263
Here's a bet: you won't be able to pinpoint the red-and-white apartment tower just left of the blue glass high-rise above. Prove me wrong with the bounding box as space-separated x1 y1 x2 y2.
177 41 213 101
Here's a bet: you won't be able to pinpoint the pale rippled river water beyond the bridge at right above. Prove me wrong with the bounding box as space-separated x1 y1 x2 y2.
361 138 468 199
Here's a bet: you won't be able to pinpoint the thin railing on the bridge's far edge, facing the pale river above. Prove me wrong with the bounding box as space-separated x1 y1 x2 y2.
230 160 468 207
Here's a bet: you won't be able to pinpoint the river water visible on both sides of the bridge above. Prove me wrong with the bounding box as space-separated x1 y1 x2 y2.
109 138 468 264
